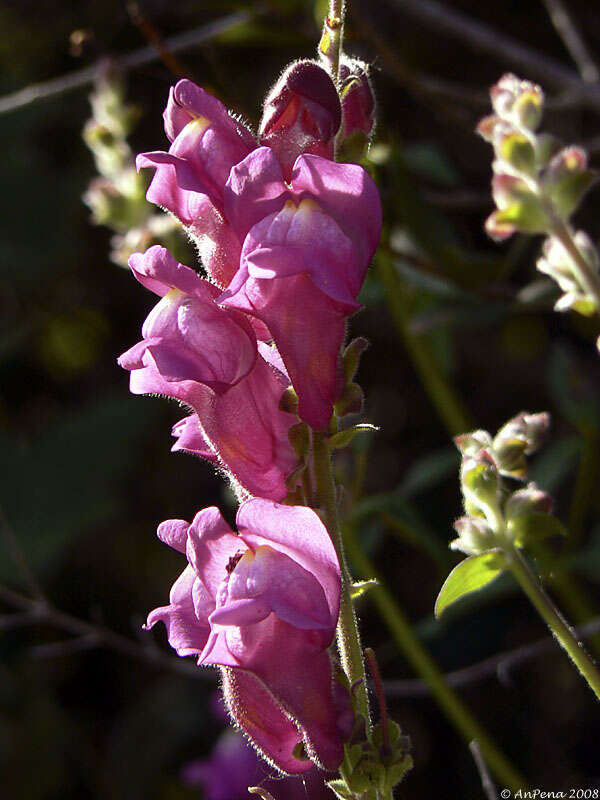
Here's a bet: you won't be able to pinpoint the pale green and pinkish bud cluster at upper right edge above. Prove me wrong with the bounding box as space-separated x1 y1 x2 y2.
477 74 599 315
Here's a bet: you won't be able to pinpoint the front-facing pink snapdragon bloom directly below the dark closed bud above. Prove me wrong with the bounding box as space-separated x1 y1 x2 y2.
219 147 381 429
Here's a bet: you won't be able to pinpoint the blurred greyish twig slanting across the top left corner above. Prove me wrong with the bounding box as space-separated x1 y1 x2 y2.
0 11 252 114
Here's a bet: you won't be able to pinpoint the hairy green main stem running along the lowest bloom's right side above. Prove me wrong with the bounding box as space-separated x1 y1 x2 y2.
313 431 371 730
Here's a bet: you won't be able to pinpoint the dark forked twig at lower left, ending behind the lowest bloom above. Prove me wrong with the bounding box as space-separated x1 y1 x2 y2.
0 585 213 680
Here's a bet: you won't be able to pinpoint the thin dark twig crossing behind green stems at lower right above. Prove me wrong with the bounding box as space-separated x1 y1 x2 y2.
385 617 600 699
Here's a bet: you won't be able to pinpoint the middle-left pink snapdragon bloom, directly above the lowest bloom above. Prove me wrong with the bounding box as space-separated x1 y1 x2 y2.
119 246 298 500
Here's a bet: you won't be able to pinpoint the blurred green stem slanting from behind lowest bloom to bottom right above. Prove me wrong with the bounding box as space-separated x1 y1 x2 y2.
345 524 527 792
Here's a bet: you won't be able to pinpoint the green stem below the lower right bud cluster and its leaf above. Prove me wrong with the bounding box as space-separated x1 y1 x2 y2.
504 546 600 700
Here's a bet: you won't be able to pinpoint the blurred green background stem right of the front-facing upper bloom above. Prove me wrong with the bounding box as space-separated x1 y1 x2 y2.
377 253 473 436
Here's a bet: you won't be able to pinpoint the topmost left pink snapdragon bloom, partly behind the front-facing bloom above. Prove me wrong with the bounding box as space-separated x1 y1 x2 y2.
136 80 256 286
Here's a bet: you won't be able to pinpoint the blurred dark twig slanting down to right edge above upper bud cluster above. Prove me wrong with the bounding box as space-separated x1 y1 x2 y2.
382 0 600 110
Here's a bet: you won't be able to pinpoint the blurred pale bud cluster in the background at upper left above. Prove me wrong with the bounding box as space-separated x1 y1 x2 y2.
83 70 184 267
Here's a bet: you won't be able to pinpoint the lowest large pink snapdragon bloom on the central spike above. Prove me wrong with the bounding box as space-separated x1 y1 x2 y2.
146 498 347 773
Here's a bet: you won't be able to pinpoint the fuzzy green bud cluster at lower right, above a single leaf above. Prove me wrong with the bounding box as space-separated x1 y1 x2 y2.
450 411 561 556
